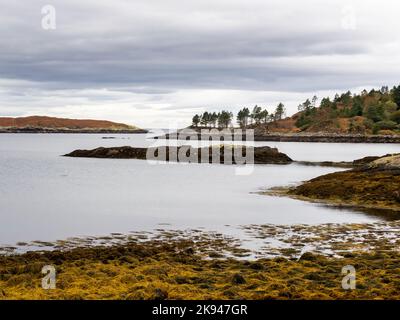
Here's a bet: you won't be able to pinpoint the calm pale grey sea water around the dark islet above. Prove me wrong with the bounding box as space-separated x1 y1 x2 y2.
0 134 400 244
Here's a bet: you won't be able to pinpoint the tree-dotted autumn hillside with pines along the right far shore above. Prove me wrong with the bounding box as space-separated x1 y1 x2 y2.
192 85 400 134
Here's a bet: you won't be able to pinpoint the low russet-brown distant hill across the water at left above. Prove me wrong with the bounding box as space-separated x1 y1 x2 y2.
0 116 144 130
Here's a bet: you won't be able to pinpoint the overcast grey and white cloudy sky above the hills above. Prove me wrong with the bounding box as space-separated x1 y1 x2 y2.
0 0 400 128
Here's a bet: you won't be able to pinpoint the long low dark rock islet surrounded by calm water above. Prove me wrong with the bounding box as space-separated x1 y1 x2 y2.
65 146 293 164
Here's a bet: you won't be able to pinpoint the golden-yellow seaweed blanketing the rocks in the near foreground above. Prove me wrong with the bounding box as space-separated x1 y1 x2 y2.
0 235 400 304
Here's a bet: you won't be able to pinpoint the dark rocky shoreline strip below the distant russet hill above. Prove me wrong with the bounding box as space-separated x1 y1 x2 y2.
0 127 149 134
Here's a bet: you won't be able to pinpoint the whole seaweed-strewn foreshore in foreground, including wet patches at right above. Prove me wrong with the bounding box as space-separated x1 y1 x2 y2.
0 223 400 300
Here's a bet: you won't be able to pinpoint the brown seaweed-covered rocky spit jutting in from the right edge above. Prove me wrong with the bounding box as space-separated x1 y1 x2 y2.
266 154 400 213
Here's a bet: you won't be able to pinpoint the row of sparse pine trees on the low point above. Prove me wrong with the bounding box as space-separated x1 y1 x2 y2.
192 103 286 128
